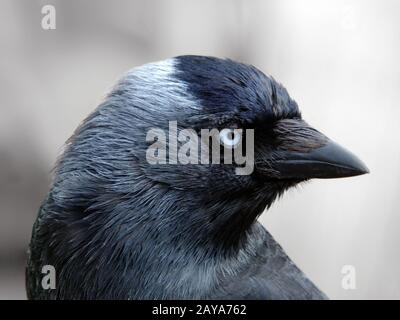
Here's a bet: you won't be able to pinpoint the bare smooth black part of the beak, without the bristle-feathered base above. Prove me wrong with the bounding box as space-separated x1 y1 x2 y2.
273 140 369 179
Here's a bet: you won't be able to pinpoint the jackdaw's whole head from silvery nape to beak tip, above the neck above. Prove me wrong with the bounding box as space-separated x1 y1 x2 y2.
54 56 368 248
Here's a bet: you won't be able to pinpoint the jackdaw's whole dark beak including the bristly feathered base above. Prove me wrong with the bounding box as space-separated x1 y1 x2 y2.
260 119 369 179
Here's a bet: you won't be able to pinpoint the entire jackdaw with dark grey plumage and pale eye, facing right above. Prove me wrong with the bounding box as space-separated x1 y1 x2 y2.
26 56 368 299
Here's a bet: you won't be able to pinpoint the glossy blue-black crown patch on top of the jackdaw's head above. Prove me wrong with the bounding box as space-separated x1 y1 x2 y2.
176 56 301 126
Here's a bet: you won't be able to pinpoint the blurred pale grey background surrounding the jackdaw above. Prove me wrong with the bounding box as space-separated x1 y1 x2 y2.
0 0 400 299
